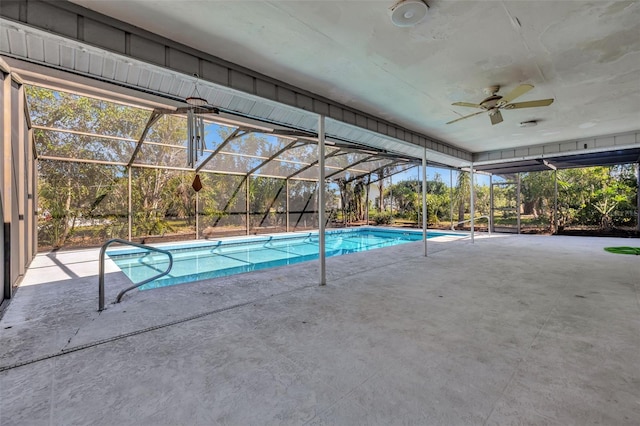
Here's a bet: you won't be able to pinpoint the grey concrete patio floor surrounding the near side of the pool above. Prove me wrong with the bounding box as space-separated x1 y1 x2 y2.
0 235 640 426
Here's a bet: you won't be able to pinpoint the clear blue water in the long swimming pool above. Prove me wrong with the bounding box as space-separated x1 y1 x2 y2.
107 228 460 290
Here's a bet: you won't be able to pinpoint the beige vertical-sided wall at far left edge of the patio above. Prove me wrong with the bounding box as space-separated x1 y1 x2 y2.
0 63 37 301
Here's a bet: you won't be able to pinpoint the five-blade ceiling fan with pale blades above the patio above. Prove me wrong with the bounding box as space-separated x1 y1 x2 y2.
447 84 553 124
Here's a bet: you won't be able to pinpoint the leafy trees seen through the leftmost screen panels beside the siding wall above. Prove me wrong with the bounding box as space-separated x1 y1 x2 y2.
26 86 149 247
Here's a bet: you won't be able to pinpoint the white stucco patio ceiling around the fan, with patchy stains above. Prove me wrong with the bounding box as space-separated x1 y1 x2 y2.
62 0 640 152
